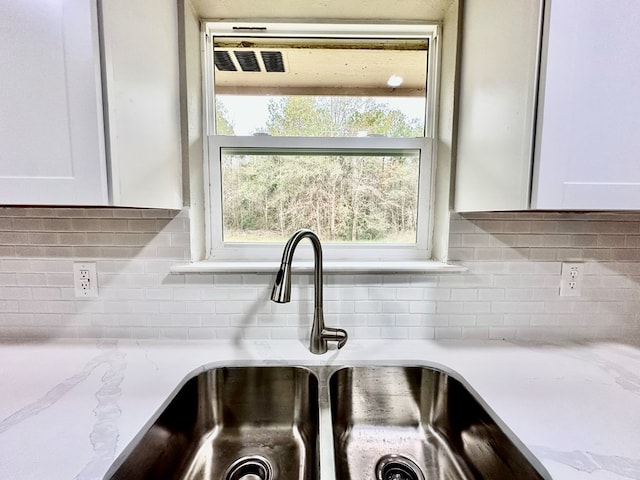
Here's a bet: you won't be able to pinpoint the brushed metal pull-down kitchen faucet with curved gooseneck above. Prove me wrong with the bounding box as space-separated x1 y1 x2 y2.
271 229 347 354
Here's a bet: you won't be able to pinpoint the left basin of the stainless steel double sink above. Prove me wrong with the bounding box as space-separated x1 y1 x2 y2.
105 366 319 480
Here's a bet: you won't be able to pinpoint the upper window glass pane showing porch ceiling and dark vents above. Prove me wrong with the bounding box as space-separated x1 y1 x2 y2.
214 37 428 137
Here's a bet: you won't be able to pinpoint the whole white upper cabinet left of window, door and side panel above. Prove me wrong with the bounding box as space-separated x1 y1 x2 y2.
0 0 182 208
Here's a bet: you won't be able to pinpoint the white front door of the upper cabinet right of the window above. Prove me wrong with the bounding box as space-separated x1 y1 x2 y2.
532 0 640 210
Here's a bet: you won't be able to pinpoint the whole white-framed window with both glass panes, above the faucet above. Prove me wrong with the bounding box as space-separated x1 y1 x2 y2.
205 23 438 261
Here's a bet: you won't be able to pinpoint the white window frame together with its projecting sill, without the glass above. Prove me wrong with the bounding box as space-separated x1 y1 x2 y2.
196 22 444 273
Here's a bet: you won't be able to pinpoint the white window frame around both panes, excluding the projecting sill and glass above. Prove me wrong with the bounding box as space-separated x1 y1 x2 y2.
203 22 440 264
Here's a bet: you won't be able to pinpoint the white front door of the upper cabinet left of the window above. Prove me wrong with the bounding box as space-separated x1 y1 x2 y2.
0 0 108 205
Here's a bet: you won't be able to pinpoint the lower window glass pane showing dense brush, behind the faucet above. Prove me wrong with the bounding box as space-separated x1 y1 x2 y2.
221 148 420 244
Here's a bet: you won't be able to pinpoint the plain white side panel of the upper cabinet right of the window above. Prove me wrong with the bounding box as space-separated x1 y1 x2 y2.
454 0 542 212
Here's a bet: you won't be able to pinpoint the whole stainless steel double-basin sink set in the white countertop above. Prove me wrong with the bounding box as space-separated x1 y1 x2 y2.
105 365 551 480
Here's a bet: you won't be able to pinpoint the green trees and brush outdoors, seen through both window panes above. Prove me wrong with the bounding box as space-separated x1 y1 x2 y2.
219 96 422 242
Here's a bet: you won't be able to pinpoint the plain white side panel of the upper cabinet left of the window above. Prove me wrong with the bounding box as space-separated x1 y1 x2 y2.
101 0 183 209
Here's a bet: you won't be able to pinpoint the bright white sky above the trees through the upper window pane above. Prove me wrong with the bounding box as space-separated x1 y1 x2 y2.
217 95 424 136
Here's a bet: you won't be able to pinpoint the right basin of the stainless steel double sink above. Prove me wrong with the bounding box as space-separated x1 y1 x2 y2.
330 366 549 480
